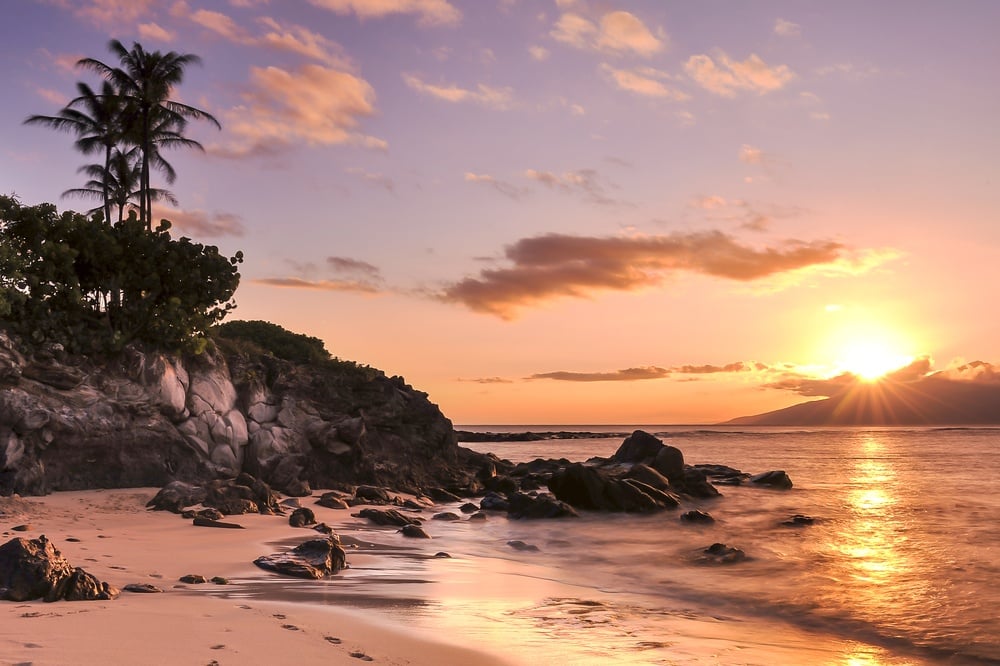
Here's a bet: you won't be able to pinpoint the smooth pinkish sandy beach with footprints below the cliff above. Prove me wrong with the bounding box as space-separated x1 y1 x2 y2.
0 488 503 666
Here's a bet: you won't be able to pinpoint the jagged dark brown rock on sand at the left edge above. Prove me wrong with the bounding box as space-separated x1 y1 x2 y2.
0 535 118 601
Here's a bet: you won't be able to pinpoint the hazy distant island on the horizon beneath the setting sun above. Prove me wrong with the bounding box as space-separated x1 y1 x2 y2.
725 373 1000 426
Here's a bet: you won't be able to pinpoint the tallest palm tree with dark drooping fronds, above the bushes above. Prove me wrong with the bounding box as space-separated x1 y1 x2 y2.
77 39 221 228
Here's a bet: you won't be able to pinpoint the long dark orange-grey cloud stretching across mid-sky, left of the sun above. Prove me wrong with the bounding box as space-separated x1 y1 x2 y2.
437 231 851 319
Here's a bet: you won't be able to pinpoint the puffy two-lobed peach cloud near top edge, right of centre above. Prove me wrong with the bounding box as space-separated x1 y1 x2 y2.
549 10 664 58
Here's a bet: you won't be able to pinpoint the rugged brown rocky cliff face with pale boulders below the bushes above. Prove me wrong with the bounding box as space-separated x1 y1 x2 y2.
0 332 482 494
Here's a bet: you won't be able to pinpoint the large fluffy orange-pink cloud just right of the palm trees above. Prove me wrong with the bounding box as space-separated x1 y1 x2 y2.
209 64 387 157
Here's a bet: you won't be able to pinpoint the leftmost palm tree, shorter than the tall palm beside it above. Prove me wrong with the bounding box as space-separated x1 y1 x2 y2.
24 81 123 224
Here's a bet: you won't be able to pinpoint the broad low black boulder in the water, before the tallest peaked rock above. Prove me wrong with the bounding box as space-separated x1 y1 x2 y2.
549 463 677 512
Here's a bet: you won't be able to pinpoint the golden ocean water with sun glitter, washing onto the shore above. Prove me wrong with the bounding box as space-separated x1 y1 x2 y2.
213 426 1000 666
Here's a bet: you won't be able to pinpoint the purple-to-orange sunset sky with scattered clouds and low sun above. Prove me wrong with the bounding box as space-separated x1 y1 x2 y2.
0 0 1000 424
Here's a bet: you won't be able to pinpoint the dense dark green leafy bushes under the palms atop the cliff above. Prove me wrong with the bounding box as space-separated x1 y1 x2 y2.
0 196 243 353
